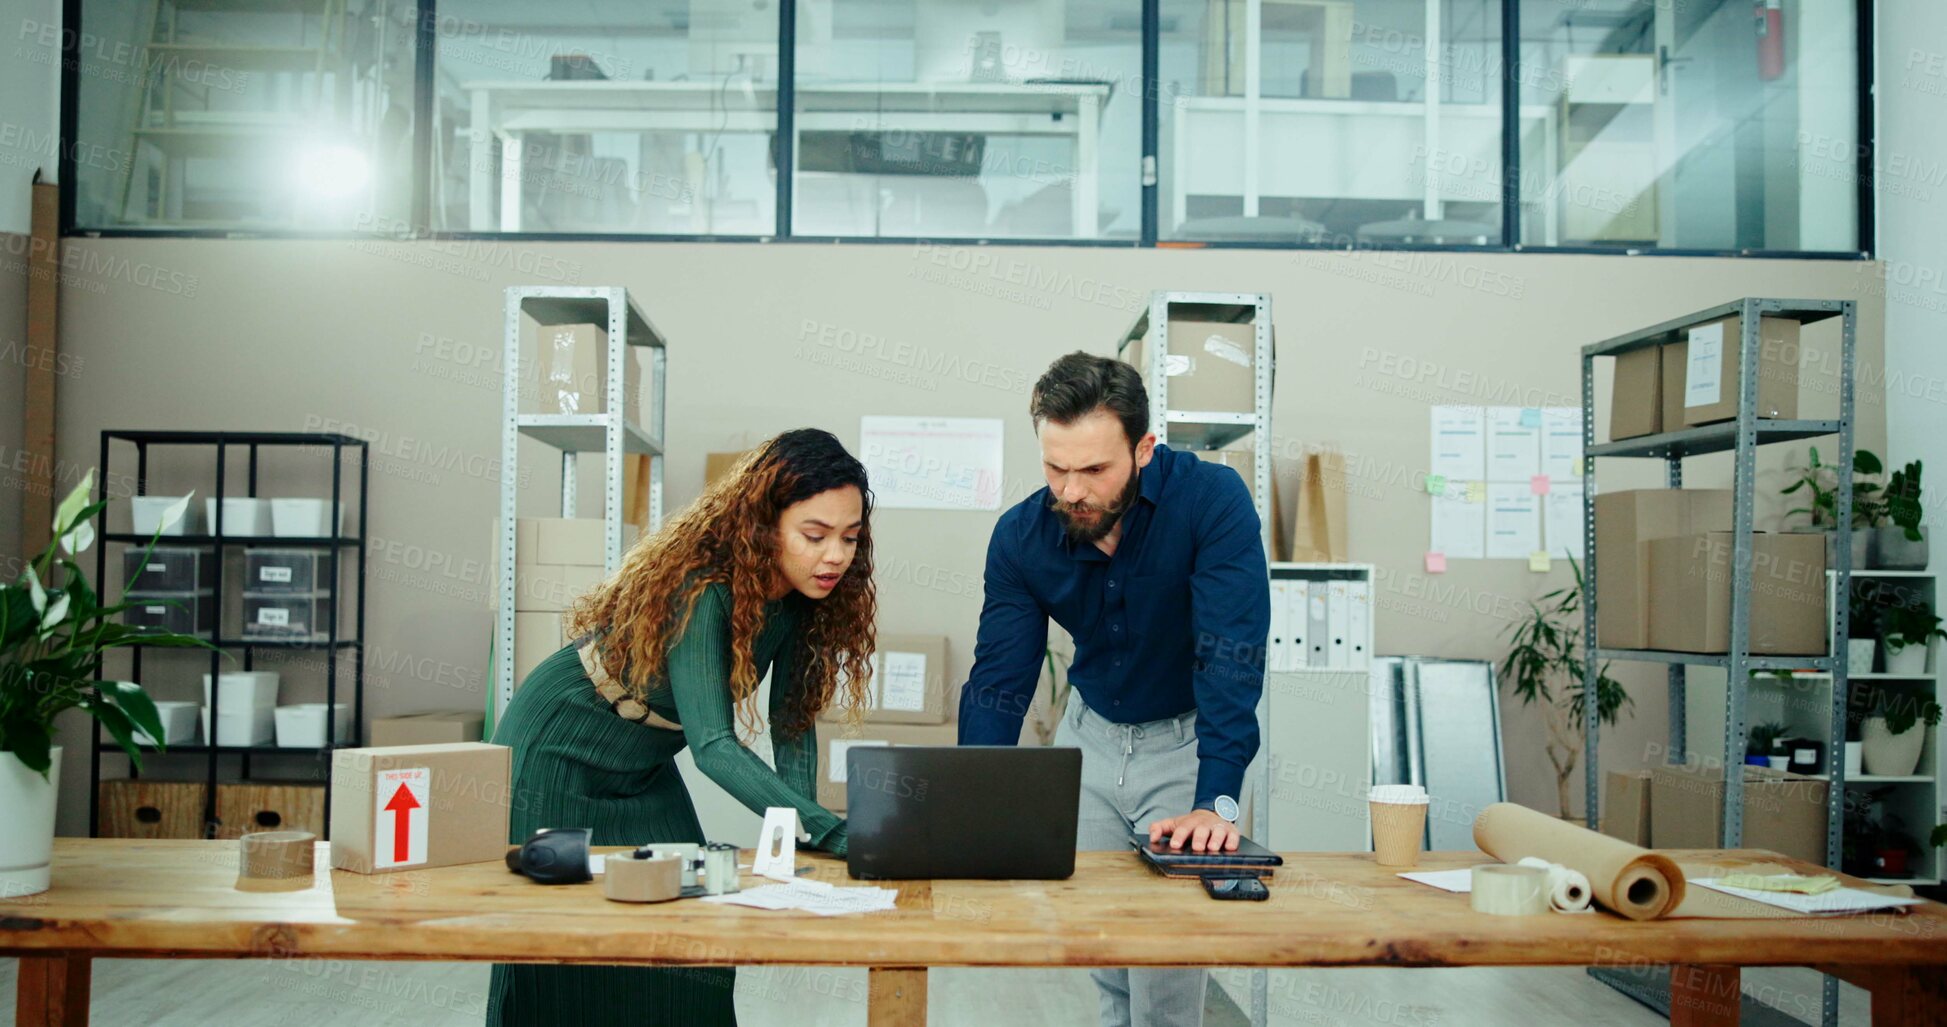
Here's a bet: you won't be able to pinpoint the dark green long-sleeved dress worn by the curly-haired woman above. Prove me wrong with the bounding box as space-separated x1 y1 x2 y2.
487 585 845 1027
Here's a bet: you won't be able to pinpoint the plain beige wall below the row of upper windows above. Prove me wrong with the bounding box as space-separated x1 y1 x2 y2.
41 240 1885 832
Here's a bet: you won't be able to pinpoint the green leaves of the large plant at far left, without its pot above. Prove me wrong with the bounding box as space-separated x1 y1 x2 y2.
0 472 210 778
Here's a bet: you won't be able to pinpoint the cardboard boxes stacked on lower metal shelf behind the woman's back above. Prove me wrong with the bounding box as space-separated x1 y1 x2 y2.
495 516 641 688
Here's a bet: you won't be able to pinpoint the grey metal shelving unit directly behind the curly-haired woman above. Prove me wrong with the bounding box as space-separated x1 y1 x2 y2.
493 286 668 721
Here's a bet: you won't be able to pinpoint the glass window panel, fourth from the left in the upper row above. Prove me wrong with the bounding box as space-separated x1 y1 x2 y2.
1157 0 1501 246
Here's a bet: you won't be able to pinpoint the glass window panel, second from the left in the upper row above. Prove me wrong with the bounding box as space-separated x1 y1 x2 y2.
432 0 779 236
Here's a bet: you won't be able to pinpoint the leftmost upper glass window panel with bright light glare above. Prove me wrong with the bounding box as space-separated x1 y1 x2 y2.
74 0 415 230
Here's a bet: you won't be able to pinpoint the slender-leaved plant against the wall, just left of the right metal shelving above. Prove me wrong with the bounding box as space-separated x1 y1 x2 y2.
1501 557 1632 818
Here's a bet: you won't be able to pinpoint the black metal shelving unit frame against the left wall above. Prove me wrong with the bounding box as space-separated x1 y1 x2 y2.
88 431 372 838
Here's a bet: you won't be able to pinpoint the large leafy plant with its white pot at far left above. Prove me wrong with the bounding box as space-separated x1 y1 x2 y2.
0 472 208 896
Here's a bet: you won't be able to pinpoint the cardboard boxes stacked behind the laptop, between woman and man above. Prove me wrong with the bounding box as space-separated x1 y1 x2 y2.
818 635 960 813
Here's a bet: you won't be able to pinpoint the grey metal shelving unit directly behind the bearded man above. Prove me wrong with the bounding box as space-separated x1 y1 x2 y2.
1116 292 1277 1027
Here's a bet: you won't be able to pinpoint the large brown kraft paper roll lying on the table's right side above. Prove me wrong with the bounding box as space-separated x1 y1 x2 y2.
1474 803 1684 920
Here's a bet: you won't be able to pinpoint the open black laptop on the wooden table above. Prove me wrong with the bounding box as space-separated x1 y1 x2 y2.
845 744 1083 881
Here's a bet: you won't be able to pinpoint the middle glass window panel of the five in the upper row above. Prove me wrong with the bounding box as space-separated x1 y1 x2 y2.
792 0 1143 240
